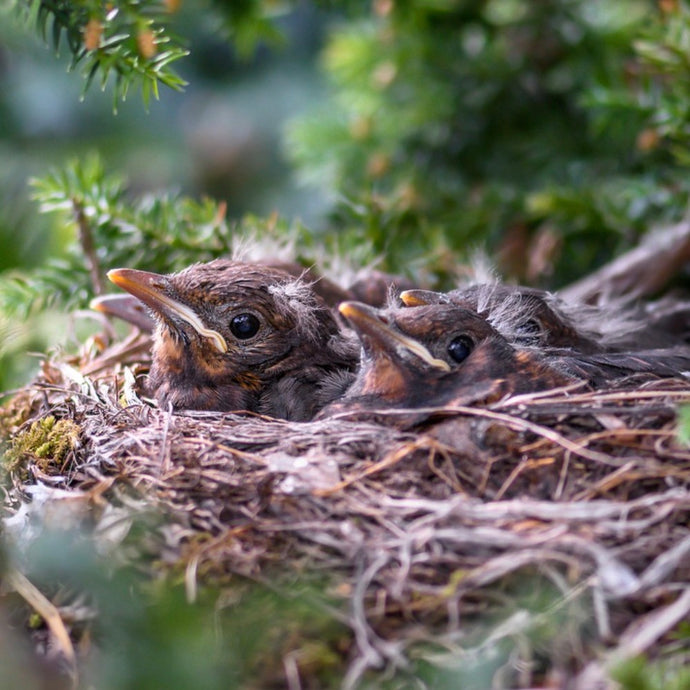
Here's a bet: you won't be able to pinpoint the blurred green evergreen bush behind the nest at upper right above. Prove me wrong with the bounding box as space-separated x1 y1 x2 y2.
288 0 690 286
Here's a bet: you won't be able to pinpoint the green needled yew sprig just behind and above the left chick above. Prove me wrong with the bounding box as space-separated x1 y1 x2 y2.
0 156 354 319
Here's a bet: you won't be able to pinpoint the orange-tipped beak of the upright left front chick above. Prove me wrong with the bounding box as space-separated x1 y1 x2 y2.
108 268 228 352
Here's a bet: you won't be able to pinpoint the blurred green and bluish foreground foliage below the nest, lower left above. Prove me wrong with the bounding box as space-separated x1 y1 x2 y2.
0 511 349 690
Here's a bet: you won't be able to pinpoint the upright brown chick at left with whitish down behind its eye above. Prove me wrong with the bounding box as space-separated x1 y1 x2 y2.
108 259 358 421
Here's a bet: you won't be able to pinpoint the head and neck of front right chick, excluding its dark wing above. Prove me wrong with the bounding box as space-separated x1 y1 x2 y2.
324 302 574 414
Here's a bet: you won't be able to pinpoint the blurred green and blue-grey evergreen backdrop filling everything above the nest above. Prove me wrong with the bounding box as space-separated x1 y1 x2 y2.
0 0 690 390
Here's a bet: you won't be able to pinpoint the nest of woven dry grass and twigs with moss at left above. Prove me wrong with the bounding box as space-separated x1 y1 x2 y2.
3 330 690 689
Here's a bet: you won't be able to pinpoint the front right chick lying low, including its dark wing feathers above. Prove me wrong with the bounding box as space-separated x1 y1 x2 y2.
323 302 690 415
